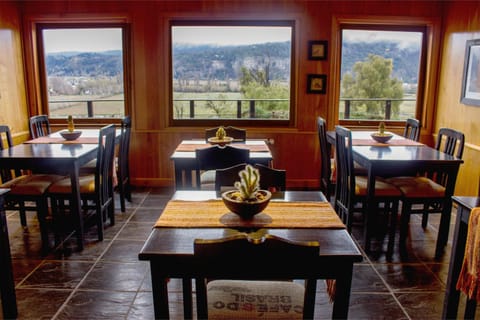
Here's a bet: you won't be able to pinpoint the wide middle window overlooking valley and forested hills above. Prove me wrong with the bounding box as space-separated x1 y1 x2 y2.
170 20 294 126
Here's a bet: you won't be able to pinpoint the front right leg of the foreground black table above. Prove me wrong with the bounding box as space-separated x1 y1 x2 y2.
332 263 353 319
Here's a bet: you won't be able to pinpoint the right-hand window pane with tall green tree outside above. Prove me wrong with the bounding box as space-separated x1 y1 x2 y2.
338 24 426 123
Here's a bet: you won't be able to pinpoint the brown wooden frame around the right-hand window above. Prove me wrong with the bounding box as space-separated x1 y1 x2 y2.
328 16 440 131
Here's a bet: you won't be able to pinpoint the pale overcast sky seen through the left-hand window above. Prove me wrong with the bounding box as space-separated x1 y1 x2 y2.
43 28 122 53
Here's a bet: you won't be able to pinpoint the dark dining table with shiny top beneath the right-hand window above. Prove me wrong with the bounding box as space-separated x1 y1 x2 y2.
327 131 463 257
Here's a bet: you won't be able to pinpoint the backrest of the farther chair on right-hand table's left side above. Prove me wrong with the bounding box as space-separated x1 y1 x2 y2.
317 117 332 199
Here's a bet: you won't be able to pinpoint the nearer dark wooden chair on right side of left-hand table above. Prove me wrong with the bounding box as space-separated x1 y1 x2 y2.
48 124 115 246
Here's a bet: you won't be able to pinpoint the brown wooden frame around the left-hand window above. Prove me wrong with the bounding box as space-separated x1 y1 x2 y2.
35 21 131 126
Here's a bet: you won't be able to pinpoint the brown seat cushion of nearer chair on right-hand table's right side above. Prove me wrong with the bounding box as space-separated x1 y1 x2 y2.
386 177 445 198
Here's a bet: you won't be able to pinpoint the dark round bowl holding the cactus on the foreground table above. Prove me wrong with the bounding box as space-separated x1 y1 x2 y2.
222 190 272 220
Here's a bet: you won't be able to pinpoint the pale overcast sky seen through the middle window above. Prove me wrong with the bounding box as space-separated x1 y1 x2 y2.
172 26 292 45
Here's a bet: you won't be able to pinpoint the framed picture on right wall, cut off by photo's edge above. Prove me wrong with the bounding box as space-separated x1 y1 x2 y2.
460 39 480 106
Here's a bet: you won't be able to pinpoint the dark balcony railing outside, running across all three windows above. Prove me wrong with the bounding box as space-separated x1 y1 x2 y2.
49 98 416 120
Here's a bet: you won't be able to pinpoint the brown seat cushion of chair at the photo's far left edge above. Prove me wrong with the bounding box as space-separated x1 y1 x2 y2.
0 174 64 196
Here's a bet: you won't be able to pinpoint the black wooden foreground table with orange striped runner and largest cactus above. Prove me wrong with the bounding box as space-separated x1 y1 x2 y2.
139 191 362 319
